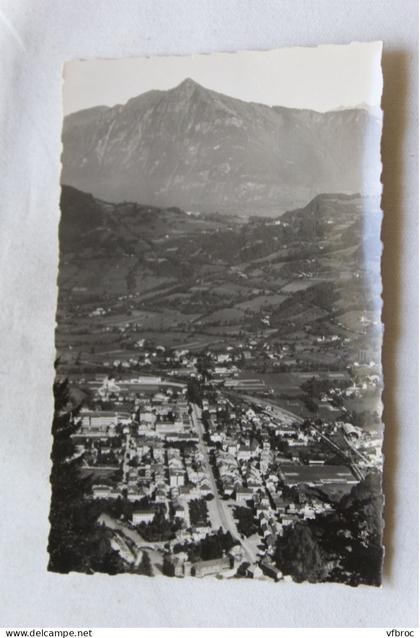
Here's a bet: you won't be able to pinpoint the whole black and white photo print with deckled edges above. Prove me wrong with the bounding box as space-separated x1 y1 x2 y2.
48 42 384 587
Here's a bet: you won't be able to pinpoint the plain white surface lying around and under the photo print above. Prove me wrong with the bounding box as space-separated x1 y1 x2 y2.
0 0 418 627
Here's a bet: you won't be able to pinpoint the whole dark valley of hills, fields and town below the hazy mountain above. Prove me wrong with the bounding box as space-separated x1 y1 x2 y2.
53 187 382 584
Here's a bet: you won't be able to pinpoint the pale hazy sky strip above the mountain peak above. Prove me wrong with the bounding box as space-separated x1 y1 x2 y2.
63 42 382 115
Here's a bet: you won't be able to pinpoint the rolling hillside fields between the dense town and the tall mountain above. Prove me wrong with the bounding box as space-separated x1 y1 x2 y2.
56 188 380 440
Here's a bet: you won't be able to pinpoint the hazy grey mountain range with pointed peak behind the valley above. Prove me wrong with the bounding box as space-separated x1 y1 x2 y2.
62 79 380 217
